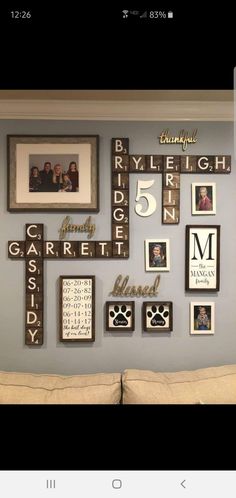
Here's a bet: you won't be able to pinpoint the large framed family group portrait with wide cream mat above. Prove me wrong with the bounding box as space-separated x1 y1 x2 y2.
7 135 99 212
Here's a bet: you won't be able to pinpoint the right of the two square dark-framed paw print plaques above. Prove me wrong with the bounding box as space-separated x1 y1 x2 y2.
143 301 173 332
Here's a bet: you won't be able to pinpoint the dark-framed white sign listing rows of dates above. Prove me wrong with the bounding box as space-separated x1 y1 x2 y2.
59 275 95 342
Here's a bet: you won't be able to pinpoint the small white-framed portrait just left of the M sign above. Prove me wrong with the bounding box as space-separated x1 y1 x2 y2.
145 239 170 271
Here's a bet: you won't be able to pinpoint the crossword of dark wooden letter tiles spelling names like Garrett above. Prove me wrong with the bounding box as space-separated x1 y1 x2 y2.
8 138 231 346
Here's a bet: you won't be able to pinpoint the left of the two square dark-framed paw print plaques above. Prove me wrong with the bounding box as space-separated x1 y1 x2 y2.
106 301 135 332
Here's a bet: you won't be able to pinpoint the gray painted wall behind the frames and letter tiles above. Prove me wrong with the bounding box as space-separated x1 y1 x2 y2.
0 120 236 374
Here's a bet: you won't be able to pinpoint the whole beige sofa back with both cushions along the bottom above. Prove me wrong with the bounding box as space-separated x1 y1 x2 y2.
0 365 236 404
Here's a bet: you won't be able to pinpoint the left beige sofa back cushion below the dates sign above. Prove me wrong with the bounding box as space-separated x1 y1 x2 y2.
0 372 121 404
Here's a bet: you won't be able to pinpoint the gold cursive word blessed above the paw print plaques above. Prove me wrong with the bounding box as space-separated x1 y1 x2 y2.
109 275 161 297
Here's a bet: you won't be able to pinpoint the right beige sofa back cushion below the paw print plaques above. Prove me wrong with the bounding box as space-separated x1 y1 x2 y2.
122 365 236 404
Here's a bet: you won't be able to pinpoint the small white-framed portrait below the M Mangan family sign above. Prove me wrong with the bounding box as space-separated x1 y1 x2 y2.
190 301 215 335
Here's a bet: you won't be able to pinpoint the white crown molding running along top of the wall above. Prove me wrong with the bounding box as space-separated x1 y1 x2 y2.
0 99 234 121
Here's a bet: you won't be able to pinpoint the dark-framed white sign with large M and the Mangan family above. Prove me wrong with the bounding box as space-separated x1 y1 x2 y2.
185 225 220 292
